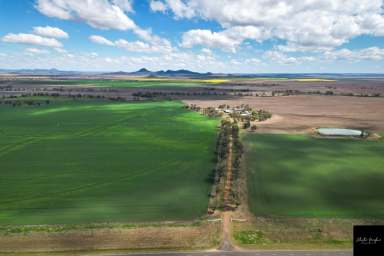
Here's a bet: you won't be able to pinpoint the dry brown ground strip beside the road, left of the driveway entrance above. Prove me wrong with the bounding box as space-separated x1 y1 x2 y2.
0 222 221 253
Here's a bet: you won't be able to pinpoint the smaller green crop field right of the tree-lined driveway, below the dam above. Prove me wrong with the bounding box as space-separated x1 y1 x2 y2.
243 134 384 218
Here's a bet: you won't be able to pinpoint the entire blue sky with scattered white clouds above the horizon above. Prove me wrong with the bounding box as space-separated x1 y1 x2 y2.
0 0 384 73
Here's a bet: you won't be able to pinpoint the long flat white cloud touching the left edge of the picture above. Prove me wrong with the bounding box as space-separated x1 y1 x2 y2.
2 33 62 48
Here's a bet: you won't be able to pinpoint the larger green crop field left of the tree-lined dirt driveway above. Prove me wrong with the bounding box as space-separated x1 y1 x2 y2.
0 99 218 225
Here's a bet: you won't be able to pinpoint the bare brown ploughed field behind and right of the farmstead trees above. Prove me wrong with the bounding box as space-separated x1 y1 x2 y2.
184 95 384 133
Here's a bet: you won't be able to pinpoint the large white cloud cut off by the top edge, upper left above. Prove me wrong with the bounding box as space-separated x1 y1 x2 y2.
36 0 136 30
